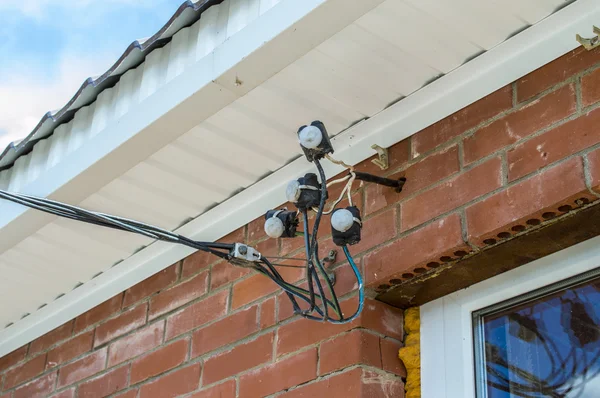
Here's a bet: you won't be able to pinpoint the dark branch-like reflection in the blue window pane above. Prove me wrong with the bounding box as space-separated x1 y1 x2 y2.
485 286 600 398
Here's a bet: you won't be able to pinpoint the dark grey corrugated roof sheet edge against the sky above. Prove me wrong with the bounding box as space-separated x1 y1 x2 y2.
0 0 223 170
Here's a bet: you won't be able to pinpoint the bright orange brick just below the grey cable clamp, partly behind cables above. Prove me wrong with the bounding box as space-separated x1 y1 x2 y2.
231 268 304 309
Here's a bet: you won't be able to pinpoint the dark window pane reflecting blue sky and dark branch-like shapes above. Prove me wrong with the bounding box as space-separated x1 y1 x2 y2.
474 278 600 398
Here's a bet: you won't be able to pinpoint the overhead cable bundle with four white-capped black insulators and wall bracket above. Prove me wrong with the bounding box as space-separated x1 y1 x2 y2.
0 121 405 323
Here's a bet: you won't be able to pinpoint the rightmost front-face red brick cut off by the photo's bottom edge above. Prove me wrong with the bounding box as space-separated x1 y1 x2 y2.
278 368 360 398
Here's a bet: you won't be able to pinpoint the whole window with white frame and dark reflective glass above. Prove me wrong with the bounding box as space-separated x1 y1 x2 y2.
421 237 600 398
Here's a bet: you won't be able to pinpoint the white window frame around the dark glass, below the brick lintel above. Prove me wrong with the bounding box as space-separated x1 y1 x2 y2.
421 237 600 398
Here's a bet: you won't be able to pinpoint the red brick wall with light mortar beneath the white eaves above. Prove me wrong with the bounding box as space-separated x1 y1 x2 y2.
0 45 600 398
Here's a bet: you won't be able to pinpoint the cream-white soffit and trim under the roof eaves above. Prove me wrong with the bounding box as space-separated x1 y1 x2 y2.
0 0 600 356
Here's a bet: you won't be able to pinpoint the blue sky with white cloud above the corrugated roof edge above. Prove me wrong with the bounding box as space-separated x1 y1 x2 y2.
0 0 183 152
